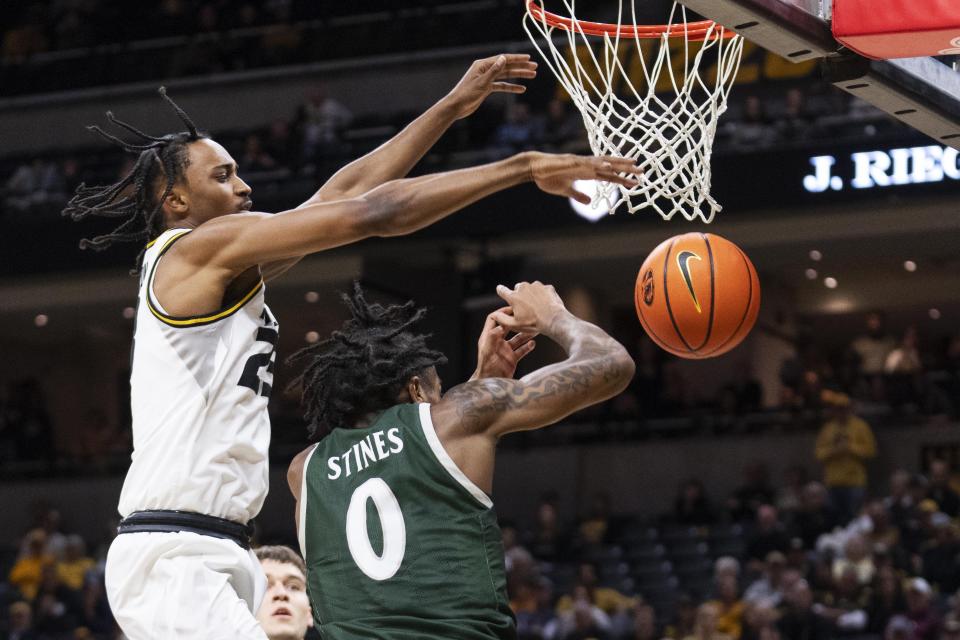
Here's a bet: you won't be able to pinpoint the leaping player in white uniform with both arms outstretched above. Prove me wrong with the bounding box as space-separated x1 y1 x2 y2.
64 55 639 640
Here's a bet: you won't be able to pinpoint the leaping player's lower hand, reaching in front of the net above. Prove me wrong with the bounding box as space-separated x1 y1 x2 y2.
530 152 642 204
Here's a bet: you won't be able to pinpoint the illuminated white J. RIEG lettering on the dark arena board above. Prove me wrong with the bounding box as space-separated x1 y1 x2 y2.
803 145 960 193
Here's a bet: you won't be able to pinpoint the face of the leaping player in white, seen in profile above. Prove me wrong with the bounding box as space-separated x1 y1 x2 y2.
186 139 253 223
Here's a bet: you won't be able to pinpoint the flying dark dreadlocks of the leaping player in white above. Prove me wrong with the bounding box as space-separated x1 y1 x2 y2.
63 87 208 272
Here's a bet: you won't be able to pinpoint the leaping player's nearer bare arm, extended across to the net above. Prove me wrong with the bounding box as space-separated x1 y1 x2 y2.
200 152 640 278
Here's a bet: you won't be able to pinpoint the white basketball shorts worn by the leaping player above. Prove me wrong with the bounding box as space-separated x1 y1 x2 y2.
106 531 267 640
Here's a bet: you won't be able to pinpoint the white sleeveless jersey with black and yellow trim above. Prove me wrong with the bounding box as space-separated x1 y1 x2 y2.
119 229 279 523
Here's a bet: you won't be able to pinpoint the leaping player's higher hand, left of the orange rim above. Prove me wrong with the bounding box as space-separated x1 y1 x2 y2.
444 53 537 118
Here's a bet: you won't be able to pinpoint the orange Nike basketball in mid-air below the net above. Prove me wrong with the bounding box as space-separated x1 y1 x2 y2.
633 233 760 359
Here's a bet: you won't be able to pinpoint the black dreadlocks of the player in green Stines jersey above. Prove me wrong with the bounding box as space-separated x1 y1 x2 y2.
287 282 447 440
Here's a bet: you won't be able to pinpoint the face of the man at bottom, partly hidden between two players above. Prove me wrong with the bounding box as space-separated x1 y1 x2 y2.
257 560 313 640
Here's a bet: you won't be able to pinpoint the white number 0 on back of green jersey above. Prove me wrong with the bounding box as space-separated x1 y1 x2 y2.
347 478 407 581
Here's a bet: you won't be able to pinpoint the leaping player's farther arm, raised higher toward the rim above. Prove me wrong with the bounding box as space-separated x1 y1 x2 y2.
261 54 537 280
